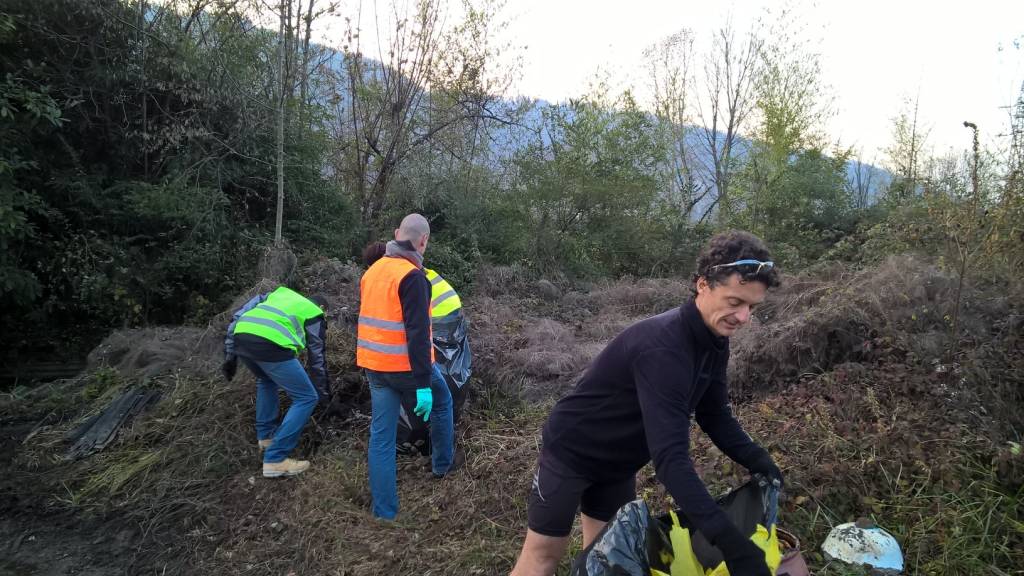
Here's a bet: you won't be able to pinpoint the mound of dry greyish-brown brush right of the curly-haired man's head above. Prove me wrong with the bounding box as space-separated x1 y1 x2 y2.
729 257 966 394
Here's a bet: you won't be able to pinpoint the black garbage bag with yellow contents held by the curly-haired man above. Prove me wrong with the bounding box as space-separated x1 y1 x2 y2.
570 480 781 576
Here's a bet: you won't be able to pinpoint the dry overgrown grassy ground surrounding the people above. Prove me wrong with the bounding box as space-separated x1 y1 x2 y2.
3 256 1024 575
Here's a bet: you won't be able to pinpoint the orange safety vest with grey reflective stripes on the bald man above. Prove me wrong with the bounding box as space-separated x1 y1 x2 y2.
355 256 434 372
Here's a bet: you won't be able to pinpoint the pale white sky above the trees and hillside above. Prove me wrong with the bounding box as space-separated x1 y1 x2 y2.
315 0 1024 160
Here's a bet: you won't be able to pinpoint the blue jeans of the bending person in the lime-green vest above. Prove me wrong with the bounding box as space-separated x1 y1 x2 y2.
242 358 319 463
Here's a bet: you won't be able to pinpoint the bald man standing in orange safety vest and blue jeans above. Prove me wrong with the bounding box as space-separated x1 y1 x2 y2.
355 214 455 520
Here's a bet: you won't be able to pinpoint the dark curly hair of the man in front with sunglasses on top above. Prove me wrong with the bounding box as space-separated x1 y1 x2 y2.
693 230 781 288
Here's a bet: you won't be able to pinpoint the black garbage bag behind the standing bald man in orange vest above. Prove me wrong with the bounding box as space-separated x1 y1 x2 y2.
395 310 473 455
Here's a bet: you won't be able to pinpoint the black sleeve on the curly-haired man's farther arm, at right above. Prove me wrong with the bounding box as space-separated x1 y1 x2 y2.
695 354 769 468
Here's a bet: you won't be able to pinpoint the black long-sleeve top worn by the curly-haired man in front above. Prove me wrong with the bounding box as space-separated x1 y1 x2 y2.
544 301 769 541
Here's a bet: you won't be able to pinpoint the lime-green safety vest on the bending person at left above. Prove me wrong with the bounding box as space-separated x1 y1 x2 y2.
234 286 324 354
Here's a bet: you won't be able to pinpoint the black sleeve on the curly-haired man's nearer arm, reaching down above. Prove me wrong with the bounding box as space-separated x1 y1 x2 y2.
633 348 735 541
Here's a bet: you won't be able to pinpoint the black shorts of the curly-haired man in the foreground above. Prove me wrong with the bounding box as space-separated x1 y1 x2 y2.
526 449 636 537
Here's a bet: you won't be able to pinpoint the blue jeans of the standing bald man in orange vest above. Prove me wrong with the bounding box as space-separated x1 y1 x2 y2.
366 364 455 520
